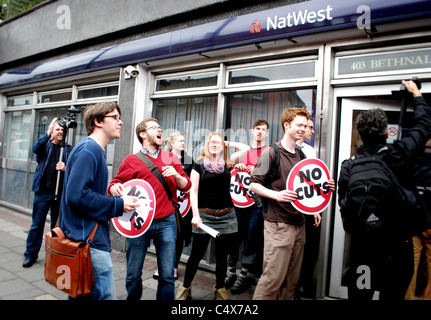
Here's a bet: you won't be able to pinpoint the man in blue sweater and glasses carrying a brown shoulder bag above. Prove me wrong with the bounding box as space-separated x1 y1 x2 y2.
59 102 138 300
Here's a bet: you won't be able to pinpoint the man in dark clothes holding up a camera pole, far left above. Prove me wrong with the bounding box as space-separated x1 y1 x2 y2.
22 118 72 268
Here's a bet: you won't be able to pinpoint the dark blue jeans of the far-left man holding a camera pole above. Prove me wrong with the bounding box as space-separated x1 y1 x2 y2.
24 192 60 260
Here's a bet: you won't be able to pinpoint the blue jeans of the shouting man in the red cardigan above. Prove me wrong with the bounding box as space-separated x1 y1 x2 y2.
126 214 177 300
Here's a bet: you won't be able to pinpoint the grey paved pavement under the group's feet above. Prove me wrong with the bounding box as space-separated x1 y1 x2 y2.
0 206 255 300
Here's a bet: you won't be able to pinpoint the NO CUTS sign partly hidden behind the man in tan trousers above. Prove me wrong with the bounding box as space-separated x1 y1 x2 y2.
230 169 254 208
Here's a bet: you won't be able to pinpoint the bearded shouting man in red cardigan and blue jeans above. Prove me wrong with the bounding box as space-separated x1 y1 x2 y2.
108 118 191 300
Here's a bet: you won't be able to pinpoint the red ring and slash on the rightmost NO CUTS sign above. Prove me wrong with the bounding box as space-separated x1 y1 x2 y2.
286 159 332 214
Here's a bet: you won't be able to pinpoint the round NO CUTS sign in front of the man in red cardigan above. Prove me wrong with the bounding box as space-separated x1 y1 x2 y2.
112 179 156 238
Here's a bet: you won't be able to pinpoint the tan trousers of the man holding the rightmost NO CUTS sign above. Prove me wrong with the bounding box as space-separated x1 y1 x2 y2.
253 221 305 300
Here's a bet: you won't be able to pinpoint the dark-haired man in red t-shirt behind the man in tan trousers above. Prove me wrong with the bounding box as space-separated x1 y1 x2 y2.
225 119 269 294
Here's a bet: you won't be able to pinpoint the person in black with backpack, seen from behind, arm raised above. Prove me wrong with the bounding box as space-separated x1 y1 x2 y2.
338 81 431 300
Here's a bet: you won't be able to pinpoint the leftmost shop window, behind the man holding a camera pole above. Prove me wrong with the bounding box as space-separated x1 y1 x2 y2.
0 81 119 209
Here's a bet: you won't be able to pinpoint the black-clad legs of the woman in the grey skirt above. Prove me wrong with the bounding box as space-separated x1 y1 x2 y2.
183 233 236 289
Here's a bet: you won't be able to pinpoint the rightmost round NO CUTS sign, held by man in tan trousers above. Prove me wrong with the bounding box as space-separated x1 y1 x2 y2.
286 159 332 214
